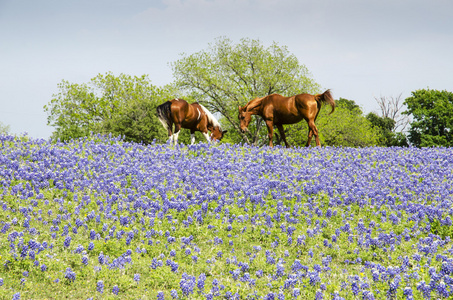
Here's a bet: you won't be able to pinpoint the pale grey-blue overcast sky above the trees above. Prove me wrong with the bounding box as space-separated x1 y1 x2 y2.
0 0 453 138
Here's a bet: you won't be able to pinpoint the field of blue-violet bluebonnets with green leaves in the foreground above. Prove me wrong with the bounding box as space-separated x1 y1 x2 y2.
0 136 453 299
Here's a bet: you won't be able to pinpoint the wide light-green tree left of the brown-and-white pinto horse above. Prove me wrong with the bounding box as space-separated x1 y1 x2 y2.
44 73 170 142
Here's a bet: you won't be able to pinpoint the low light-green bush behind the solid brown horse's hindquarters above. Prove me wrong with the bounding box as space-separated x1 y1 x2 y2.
287 98 381 147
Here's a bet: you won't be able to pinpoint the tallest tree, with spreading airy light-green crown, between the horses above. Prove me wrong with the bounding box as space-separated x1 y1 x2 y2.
171 38 319 145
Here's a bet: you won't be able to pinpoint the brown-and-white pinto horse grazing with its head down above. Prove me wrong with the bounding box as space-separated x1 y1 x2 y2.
157 98 227 145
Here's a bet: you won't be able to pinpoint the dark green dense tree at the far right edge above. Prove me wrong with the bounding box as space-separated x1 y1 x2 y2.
403 89 453 147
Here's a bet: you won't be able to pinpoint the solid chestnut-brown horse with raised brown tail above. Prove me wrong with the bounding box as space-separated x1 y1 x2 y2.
238 90 335 148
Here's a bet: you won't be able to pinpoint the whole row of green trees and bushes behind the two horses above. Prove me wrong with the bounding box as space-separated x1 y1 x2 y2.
44 38 453 147
